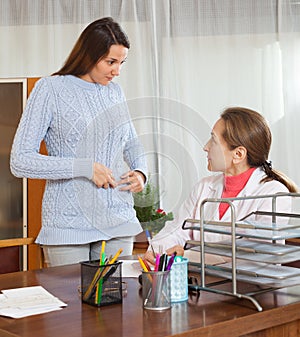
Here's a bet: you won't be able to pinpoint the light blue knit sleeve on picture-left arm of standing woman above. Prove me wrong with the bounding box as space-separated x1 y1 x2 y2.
10 78 93 179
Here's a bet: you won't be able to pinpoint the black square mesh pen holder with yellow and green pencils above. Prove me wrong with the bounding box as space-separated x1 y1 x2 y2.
81 260 122 307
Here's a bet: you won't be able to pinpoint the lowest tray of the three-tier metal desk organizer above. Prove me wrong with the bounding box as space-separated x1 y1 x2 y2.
205 261 300 288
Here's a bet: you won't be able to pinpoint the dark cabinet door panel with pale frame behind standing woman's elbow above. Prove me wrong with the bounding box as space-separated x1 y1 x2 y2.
0 78 27 272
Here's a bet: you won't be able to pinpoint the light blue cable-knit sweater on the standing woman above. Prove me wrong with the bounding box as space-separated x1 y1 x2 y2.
10 75 147 245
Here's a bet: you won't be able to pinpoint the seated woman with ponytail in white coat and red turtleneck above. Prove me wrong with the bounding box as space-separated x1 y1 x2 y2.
145 107 297 263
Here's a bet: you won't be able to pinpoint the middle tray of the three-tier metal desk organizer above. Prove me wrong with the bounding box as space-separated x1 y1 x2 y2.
188 239 300 264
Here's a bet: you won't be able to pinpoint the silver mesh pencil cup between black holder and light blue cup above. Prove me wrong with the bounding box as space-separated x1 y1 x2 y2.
142 270 171 311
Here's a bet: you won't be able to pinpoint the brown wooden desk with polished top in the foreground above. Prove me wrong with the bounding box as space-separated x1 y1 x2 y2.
0 265 300 337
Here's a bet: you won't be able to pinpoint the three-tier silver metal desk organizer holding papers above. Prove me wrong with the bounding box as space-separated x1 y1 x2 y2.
182 193 300 311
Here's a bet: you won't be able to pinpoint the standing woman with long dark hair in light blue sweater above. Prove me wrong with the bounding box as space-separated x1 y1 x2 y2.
10 18 147 266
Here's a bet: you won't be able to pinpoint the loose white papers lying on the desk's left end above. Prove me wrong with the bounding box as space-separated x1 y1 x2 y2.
0 286 67 318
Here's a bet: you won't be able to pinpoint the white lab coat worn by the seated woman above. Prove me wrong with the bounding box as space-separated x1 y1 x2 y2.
152 168 292 251
